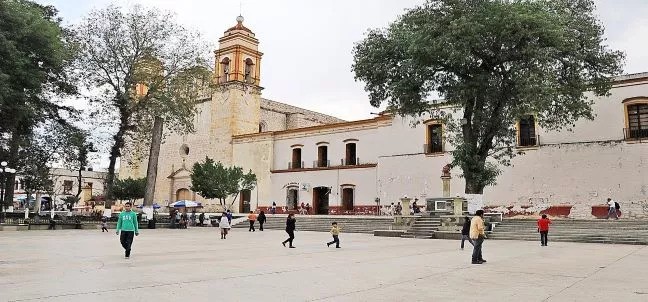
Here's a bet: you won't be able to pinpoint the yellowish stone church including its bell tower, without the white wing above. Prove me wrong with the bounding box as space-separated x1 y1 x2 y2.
119 18 342 210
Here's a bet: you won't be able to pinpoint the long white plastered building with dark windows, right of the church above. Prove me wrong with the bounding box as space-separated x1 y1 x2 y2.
240 74 648 218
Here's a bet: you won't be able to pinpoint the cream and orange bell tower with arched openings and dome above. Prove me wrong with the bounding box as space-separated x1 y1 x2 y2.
210 16 263 164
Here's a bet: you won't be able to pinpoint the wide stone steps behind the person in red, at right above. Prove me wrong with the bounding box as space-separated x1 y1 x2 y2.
488 219 648 245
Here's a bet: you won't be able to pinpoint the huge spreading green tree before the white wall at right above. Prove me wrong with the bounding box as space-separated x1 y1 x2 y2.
353 0 623 194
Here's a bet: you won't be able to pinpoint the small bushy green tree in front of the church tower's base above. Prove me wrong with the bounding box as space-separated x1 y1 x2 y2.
191 157 257 209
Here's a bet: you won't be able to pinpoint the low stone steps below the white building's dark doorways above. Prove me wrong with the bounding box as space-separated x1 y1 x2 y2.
233 215 393 234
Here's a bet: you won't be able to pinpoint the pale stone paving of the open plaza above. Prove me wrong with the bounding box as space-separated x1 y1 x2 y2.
0 228 648 302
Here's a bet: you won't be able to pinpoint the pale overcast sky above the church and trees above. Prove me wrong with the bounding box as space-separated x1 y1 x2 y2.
36 0 648 170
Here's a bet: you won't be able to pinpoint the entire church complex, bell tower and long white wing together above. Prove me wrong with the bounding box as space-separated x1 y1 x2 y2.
119 16 648 218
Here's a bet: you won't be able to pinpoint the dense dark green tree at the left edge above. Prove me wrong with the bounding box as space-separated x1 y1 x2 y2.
0 0 75 205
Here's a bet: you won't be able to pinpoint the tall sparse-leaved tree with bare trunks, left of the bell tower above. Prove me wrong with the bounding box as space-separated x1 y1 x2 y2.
74 6 209 208
